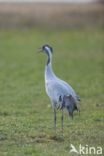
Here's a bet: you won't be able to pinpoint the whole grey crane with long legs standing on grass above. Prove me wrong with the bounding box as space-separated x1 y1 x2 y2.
38 44 80 132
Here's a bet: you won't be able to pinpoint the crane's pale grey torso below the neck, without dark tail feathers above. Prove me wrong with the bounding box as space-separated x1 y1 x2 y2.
45 67 77 108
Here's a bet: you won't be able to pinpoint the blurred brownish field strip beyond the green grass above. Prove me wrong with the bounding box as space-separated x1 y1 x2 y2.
0 0 104 30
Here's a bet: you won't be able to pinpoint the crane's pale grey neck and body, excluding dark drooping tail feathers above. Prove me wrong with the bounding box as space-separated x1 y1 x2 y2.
45 46 77 108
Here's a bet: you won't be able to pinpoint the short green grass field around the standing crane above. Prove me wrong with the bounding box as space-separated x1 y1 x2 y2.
0 29 104 156
